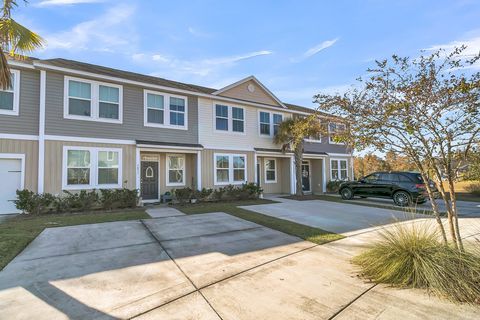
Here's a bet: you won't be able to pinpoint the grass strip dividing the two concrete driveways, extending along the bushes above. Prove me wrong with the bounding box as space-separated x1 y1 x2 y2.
176 200 343 244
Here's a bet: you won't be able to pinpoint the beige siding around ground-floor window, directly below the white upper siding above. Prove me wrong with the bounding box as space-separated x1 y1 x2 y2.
202 149 255 188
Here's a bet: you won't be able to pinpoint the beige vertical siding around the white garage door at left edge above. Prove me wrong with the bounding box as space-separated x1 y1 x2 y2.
0 139 38 192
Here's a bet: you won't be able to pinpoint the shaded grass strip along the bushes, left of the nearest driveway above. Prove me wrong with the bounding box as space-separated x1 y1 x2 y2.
0 209 150 270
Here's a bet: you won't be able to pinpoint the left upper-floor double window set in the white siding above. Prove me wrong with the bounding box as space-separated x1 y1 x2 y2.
215 104 245 133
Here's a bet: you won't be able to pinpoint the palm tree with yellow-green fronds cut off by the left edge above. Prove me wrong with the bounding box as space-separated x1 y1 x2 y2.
0 0 44 89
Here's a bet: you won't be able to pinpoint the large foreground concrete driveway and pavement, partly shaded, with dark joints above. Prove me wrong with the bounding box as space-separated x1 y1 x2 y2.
0 213 480 320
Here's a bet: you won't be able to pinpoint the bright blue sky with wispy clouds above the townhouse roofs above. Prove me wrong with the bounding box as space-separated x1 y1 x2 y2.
13 0 480 107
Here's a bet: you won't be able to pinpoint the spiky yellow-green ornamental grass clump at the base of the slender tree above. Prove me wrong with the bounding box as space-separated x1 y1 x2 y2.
353 223 480 304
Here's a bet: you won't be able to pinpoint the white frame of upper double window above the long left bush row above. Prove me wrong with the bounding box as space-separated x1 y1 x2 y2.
63 76 123 124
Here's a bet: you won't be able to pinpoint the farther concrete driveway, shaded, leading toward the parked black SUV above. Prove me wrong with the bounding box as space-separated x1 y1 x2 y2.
243 197 431 235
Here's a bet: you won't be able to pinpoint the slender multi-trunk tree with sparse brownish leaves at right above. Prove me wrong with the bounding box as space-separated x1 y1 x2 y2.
316 46 480 250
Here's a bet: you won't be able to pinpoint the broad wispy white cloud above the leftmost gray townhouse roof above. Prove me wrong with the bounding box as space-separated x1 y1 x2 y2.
41 4 137 52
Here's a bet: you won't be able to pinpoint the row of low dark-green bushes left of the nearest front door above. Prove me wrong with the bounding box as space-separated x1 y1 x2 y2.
15 188 138 214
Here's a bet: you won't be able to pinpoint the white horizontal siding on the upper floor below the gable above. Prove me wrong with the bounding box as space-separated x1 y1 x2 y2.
198 98 291 151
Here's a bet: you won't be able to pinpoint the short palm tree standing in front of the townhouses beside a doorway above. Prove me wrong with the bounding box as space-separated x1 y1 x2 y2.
274 114 322 196
